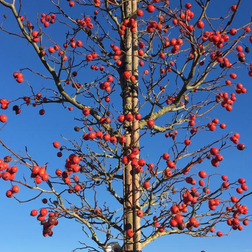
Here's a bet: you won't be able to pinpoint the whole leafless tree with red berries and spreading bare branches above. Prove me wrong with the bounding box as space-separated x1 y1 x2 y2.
0 0 252 252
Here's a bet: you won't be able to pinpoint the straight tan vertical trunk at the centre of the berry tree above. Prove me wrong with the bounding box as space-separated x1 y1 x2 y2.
121 0 141 252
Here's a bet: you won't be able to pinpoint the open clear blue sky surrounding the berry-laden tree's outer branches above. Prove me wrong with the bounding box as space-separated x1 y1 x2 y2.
0 0 252 252
